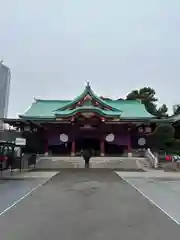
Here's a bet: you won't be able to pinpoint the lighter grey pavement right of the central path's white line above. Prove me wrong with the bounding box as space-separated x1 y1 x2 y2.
116 170 180 225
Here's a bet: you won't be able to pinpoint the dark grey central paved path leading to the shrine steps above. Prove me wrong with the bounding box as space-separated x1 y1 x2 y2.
0 169 180 240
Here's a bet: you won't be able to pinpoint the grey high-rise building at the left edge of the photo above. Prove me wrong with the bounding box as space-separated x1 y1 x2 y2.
0 62 11 118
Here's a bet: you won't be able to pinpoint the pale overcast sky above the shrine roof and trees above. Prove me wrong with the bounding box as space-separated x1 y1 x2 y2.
0 0 180 117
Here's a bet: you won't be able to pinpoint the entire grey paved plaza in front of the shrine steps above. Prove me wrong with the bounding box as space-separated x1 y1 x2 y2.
0 169 180 240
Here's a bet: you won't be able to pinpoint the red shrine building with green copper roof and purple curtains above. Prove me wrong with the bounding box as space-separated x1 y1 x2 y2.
3 84 170 156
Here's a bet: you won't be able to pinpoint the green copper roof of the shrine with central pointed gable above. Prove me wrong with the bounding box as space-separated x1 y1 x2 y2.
20 85 154 119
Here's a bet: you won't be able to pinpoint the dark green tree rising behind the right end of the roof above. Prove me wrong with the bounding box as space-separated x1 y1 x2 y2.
126 87 168 117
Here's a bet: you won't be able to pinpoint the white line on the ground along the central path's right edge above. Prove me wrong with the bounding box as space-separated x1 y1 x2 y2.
115 172 180 225
